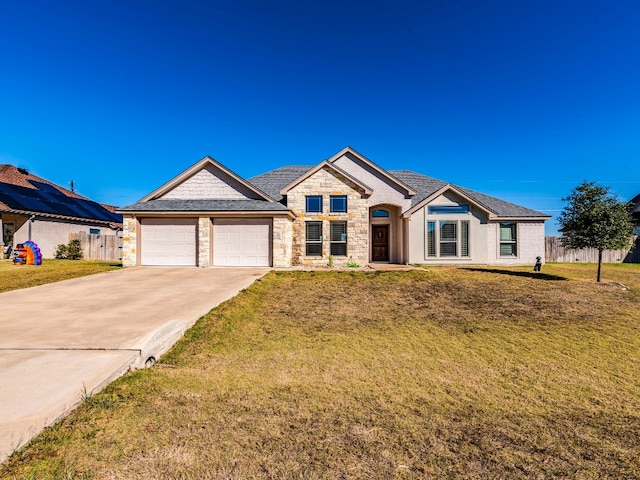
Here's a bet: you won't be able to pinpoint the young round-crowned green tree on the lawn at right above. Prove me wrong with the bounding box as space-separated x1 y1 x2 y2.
558 181 633 282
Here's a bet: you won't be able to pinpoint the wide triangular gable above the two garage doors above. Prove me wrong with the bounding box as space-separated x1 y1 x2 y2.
139 156 274 203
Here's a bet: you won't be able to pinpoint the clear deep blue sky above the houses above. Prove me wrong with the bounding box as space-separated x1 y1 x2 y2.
0 0 640 234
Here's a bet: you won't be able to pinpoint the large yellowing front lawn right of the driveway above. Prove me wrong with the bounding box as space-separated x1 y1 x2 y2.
0 264 640 479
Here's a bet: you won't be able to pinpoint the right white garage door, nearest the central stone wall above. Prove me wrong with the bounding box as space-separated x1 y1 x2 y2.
213 218 271 267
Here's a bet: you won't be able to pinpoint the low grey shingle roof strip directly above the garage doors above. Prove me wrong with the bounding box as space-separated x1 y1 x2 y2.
118 199 289 213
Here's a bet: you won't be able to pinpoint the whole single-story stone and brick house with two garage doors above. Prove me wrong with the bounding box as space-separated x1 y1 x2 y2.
118 147 551 267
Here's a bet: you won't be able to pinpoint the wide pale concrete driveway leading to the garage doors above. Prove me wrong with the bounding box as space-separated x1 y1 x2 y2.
0 267 269 462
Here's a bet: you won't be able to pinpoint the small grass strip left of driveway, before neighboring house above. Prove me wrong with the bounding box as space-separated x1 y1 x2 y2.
0 259 121 293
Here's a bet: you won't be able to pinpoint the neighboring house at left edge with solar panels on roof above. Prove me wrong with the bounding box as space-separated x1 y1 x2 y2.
0 165 122 258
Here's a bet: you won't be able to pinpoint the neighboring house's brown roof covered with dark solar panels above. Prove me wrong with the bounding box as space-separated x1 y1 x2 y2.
0 165 122 223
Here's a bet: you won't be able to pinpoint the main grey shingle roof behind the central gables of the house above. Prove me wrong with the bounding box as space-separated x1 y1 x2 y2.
249 165 549 218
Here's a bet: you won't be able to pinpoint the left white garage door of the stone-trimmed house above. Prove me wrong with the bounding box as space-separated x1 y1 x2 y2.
140 218 197 266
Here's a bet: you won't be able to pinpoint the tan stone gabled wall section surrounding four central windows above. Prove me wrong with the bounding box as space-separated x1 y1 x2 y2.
287 167 369 266
